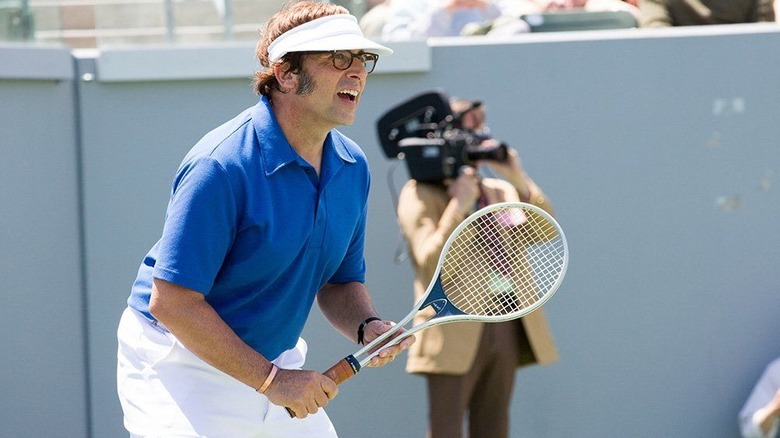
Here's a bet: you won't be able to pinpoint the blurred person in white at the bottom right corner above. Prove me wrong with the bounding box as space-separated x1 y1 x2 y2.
739 358 780 438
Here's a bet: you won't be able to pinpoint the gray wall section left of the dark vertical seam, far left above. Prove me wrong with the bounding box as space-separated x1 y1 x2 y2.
0 47 91 437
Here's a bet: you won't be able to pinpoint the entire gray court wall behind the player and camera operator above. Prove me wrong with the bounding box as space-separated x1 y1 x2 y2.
0 25 780 438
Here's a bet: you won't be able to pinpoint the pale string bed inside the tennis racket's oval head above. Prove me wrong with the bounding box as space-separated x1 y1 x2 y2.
441 206 565 316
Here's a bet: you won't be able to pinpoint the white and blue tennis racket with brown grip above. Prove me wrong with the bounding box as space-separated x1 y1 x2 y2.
288 202 569 415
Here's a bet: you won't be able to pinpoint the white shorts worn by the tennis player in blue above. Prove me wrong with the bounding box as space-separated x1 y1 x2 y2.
117 308 336 438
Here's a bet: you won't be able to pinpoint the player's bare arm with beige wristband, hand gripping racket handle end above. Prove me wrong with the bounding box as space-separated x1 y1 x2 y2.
149 279 338 418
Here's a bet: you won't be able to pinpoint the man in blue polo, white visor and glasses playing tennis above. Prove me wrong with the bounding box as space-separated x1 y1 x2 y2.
117 2 414 438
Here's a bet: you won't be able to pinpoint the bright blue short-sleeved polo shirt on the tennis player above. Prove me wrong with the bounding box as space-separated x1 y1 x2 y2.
128 97 370 360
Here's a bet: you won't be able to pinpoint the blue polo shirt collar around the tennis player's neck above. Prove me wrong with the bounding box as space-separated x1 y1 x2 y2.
252 96 355 175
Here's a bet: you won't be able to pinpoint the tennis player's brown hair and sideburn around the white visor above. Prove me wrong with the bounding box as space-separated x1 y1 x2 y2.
254 0 349 97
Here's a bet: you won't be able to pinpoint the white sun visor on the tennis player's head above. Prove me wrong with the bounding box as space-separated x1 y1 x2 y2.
268 14 393 63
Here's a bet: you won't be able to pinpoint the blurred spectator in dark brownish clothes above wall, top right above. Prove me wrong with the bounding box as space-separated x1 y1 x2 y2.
639 0 775 27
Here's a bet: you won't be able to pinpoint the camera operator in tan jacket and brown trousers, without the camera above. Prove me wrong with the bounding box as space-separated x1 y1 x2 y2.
398 98 558 438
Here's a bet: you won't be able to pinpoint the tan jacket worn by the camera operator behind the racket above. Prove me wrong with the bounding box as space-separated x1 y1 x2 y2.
398 178 558 374
